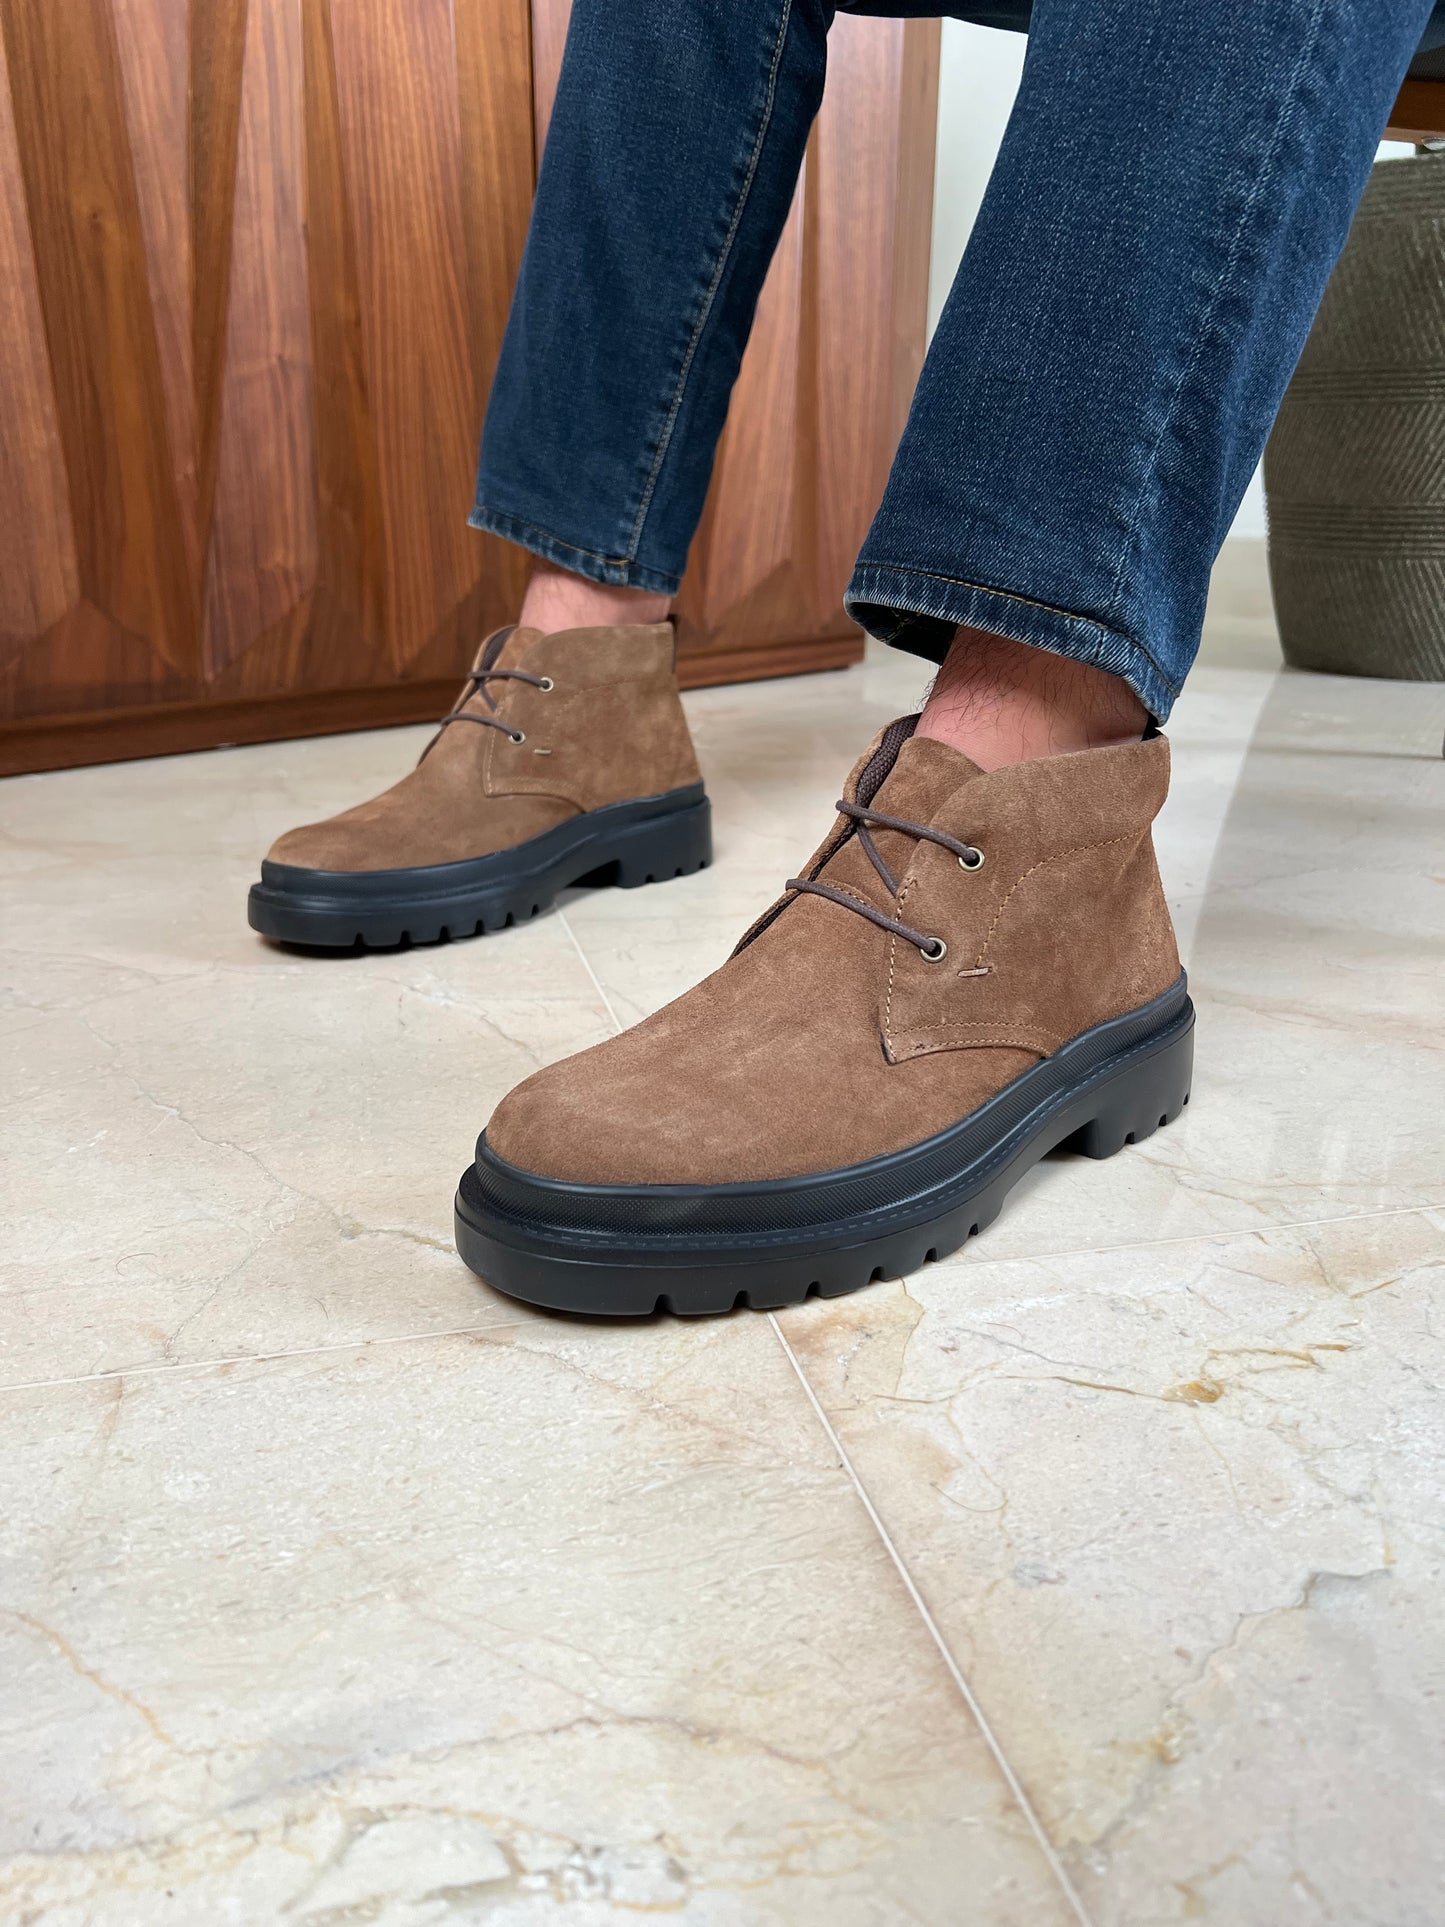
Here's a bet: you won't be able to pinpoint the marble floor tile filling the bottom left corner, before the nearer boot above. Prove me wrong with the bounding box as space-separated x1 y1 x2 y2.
0 1318 1073 1927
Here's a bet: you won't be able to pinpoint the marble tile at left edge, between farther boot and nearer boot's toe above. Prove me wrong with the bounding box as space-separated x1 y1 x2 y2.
0 732 611 1386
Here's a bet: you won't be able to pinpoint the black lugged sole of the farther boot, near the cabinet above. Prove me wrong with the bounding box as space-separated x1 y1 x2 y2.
258 782 713 950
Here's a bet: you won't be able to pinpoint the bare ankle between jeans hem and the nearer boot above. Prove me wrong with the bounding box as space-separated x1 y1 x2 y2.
919 628 1148 769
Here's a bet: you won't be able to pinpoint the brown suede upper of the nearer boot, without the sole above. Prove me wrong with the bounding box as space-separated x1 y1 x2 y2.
486 719 1179 1183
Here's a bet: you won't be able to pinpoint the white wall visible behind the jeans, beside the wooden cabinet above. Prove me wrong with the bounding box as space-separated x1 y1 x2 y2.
929 19 1412 536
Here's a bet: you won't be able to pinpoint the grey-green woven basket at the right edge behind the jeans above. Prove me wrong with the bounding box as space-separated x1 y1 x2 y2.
1264 154 1445 682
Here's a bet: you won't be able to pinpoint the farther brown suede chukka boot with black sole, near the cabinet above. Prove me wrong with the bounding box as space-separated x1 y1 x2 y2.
249 622 713 950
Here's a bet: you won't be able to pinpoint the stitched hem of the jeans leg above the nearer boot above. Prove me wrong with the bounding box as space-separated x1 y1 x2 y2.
844 557 1179 723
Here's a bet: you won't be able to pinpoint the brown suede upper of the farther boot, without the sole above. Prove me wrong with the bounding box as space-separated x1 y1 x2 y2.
268 622 699 871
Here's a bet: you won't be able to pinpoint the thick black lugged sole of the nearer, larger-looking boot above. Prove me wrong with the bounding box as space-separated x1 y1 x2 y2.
455 977 1195 1318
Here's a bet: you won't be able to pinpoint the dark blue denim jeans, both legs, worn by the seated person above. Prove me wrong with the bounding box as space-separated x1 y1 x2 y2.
472 0 1432 721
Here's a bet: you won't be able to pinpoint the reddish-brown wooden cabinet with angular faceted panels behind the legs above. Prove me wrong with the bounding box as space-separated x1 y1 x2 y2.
0 0 936 771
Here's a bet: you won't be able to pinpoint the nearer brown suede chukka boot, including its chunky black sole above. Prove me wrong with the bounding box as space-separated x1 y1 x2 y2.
457 717 1195 1316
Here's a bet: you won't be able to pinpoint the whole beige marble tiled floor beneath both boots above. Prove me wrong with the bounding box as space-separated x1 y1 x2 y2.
0 622 1445 1927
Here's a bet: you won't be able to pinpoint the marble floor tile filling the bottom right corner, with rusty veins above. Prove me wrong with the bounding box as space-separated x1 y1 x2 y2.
780 1212 1445 1927
